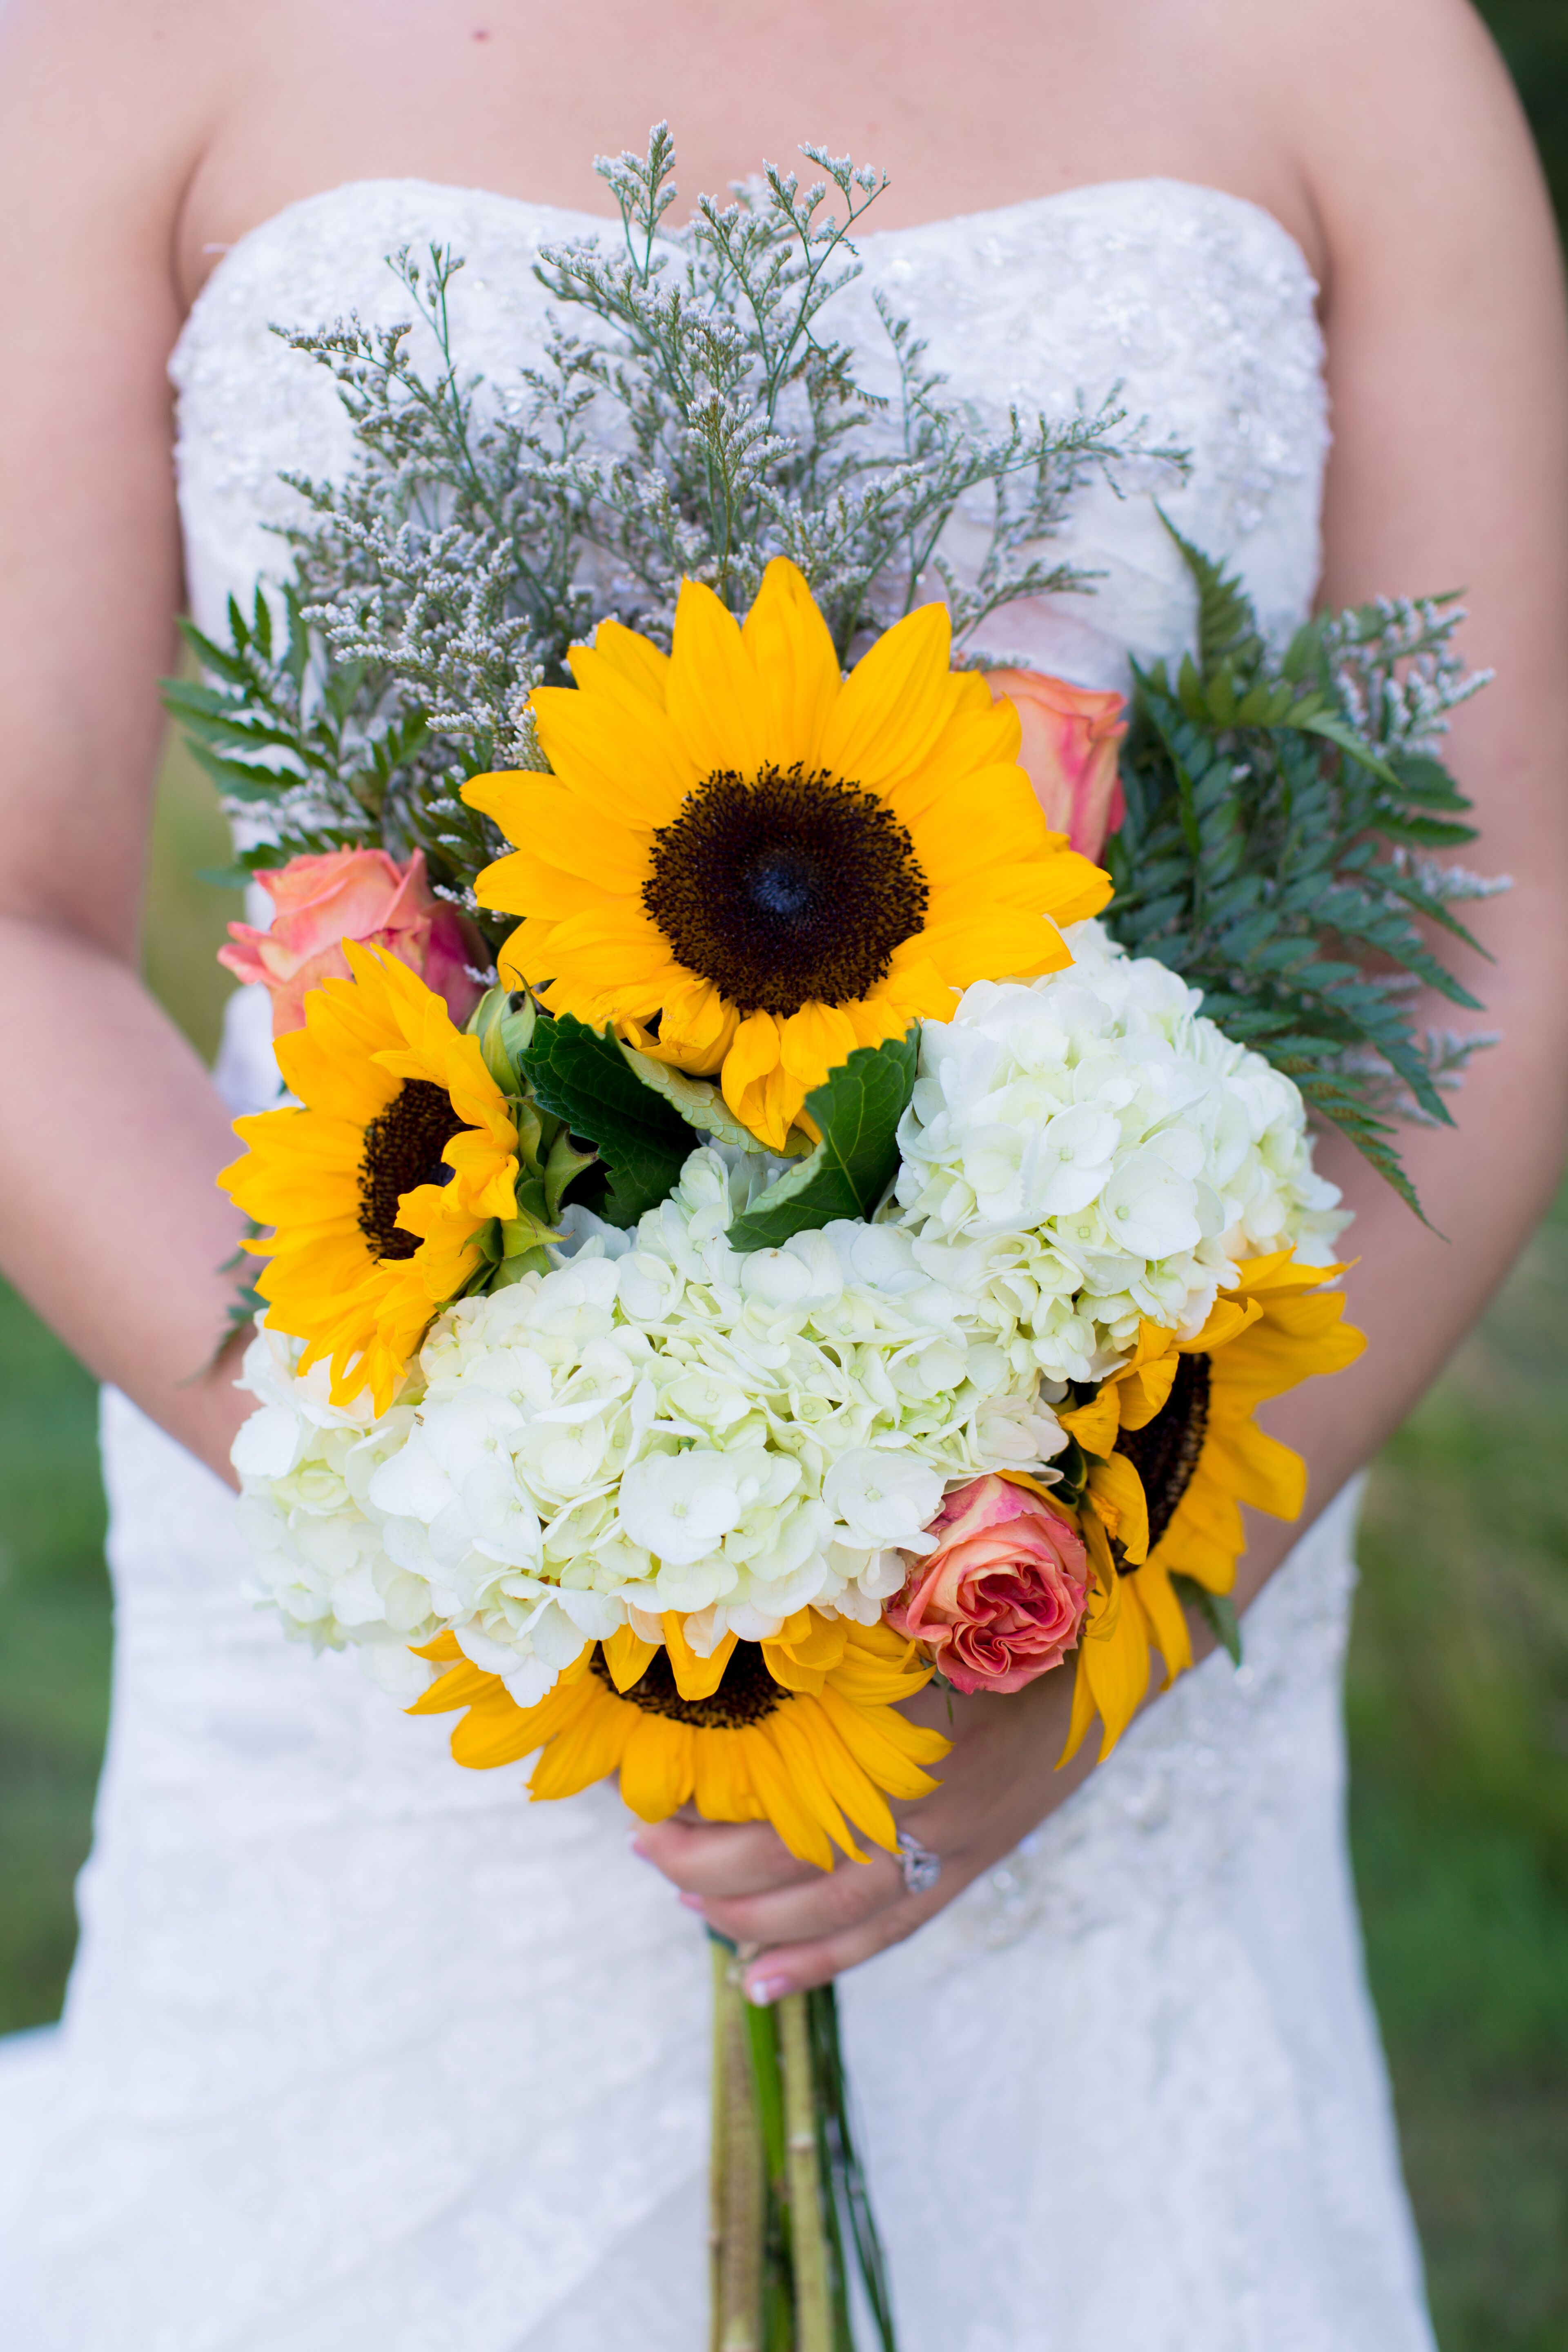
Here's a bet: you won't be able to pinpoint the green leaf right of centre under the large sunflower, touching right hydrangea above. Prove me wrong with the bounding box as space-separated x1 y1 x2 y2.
729 1028 919 1249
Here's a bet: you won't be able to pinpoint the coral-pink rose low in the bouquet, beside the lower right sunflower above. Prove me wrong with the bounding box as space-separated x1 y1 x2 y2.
884 1477 1091 1691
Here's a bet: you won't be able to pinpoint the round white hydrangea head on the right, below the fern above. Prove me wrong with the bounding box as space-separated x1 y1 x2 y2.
893 922 1350 1381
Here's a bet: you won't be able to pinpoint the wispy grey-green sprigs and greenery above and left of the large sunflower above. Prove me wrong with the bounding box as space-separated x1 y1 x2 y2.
167 127 1185 922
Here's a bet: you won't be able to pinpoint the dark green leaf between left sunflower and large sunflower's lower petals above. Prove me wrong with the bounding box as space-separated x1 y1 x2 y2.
522 1014 703 1225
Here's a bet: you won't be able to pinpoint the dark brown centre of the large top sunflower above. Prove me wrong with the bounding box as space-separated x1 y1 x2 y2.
642 764 931 1018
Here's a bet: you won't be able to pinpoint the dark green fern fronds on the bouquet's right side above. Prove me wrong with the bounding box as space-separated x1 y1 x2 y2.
1105 532 1493 1207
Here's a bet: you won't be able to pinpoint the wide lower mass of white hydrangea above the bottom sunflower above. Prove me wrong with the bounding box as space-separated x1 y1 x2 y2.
235 1150 1062 1705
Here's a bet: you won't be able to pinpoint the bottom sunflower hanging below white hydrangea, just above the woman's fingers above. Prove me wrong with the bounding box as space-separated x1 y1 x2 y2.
409 1609 950 1870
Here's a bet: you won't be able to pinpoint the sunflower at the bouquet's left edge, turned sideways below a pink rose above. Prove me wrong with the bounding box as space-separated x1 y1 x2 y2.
218 941 517 1414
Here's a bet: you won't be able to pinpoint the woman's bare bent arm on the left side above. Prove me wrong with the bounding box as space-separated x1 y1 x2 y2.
0 0 242 1468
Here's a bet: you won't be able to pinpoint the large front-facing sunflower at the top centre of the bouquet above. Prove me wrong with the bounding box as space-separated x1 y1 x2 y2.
463 557 1109 1150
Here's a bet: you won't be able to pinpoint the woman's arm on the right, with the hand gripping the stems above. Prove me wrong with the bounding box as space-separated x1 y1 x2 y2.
639 0 1568 1992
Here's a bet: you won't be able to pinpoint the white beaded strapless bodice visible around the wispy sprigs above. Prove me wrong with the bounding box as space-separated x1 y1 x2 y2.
172 179 1328 687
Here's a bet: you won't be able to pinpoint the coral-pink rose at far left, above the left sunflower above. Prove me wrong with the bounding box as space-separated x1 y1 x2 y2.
218 849 489 1037
